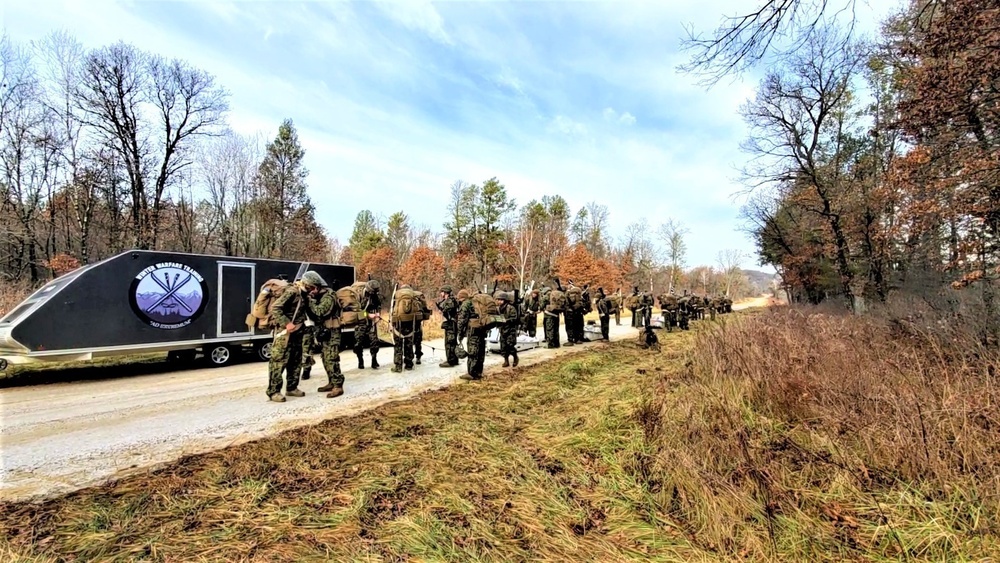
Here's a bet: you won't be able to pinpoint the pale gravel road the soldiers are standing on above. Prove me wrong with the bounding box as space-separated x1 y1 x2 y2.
0 301 766 500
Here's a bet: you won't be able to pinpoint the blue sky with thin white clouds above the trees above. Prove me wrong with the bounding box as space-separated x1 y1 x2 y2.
0 0 897 274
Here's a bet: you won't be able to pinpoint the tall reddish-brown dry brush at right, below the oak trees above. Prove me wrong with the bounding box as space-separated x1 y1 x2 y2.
640 307 1000 560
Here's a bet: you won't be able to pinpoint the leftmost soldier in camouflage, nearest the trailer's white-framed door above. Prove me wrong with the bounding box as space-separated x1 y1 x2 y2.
267 281 308 403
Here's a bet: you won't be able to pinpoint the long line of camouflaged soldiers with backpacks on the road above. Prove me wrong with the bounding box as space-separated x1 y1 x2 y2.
267 271 732 402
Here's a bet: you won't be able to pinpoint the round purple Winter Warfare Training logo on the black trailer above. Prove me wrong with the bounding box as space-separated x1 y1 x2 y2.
129 262 208 330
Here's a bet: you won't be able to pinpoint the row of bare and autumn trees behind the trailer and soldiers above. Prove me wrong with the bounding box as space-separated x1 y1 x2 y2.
0 32 760 304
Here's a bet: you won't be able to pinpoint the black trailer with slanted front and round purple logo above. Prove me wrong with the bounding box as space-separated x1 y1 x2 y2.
0 250 354 369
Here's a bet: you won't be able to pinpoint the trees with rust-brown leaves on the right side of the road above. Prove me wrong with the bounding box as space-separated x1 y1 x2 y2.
728 0 1000 319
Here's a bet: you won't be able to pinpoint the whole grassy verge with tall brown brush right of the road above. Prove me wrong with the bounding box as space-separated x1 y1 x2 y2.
0 307 1000 561
